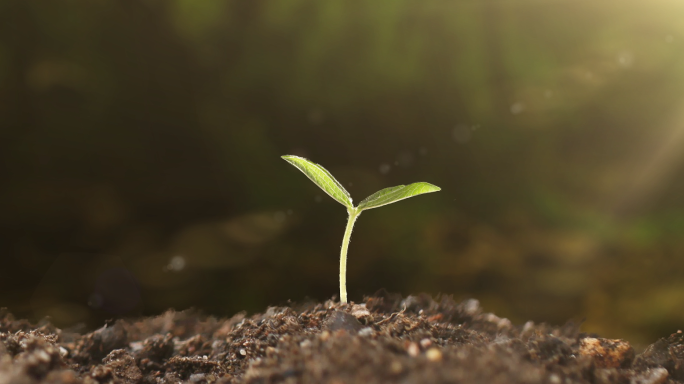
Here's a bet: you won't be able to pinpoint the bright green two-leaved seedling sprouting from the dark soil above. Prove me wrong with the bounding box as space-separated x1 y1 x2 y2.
282 155 441 303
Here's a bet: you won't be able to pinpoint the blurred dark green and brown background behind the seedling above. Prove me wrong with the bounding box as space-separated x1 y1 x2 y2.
0 0 684 344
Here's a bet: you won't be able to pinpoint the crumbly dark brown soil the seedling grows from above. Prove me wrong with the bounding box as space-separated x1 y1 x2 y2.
0 294 684 384
